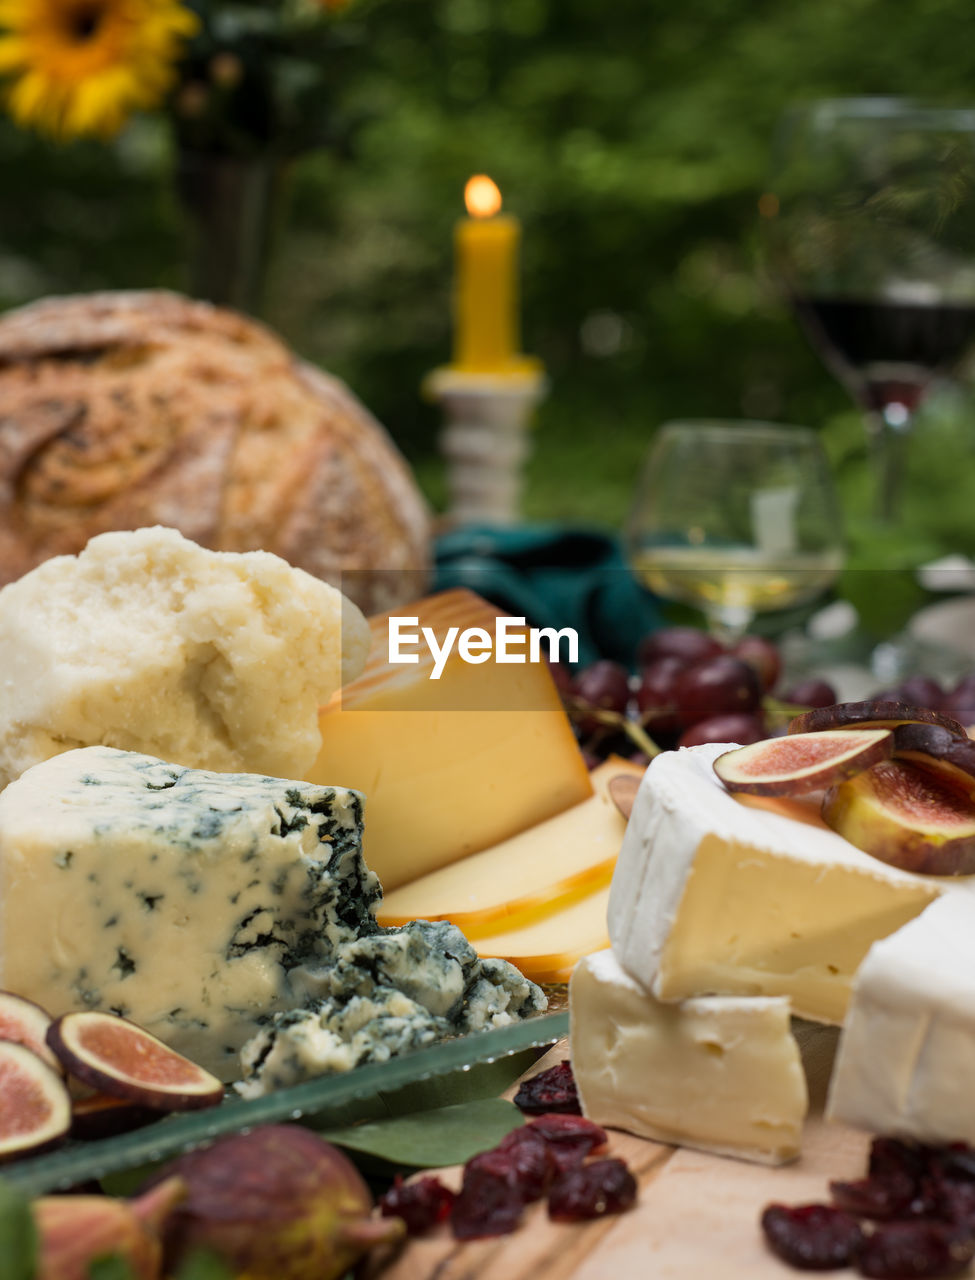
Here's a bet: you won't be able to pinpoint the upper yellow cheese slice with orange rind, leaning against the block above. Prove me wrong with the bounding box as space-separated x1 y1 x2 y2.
377 755 644 950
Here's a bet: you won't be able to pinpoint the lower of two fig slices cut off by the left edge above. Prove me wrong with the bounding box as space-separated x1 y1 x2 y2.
0 1041 72 1161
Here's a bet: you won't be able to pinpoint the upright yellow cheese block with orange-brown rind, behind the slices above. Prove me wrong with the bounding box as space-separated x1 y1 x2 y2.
307 590 592 891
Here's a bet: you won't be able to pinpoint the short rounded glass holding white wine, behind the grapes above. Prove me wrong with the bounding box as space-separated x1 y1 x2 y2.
624 421 843 644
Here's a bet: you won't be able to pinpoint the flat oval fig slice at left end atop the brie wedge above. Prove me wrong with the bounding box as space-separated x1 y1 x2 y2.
714 728 893 796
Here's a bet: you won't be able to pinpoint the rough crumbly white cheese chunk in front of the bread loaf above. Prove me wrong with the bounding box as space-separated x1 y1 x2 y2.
0 527 369 786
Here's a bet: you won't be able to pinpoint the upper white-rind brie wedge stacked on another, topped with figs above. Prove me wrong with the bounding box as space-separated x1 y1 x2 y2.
609 744 957 1023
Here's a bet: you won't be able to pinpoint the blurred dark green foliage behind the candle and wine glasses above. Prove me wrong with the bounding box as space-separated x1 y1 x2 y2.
0 0 975 596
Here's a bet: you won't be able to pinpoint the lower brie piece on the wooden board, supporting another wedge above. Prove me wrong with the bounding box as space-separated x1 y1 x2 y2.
569 951 807 1165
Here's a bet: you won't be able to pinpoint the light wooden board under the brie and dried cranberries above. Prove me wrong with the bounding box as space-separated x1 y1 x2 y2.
366 1043 869 1280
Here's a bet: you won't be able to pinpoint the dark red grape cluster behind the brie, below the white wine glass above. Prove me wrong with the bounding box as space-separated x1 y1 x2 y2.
553 627 834 765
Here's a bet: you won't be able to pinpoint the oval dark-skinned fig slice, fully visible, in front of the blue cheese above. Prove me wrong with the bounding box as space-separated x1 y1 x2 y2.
47 1010 224 1111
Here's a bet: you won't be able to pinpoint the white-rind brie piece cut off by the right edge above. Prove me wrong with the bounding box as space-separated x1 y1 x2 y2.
827 893 975 1143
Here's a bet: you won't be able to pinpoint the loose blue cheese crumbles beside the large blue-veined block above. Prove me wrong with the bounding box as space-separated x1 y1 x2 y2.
238 920 546 1098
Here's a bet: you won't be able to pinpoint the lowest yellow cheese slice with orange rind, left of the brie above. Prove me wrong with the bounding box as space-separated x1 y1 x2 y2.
471 887 609 982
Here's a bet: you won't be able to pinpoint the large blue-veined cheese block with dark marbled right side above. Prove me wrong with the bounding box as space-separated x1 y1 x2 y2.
0 746 380 1080
